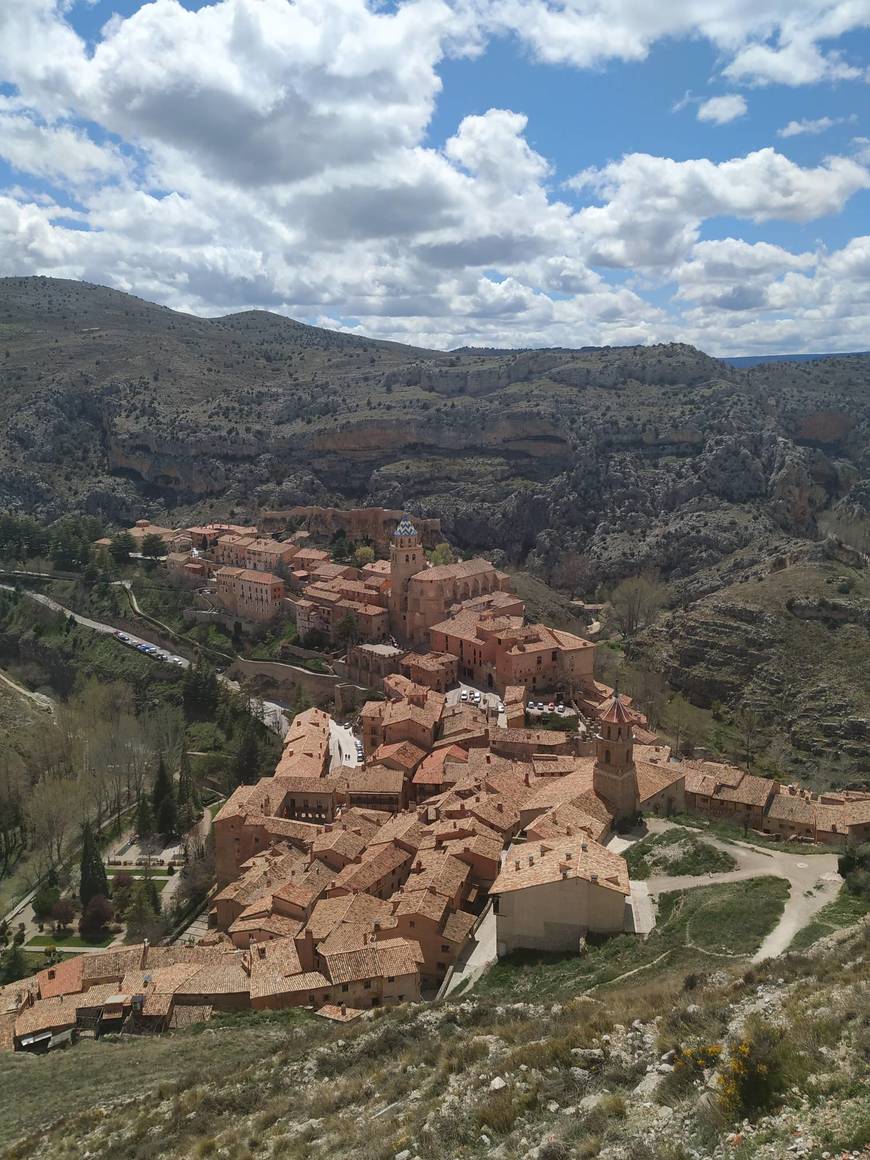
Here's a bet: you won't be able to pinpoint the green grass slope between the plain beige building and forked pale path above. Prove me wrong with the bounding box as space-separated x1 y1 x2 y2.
474 877 789 999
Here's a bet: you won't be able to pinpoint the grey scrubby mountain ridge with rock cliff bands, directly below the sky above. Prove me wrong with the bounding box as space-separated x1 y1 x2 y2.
0 278 870 587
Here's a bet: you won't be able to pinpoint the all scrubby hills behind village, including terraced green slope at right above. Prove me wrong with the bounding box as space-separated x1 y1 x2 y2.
0 278 870 785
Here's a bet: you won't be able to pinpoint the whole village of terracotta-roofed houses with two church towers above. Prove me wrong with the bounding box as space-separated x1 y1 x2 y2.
0 509 870 1049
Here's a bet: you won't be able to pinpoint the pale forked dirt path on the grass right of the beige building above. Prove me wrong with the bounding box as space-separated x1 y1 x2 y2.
646 819 842 963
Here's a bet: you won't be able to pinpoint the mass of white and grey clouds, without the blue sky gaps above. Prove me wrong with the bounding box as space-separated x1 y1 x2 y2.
0 0 870 350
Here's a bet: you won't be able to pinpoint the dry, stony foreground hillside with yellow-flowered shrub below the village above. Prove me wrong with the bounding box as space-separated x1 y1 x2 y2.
0 914 870 1160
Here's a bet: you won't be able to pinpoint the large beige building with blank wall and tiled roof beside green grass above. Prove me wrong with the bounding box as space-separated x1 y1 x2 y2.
490 839 630 957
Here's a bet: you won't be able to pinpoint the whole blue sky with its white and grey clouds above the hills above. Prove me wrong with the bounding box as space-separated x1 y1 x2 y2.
0 0 870 354
